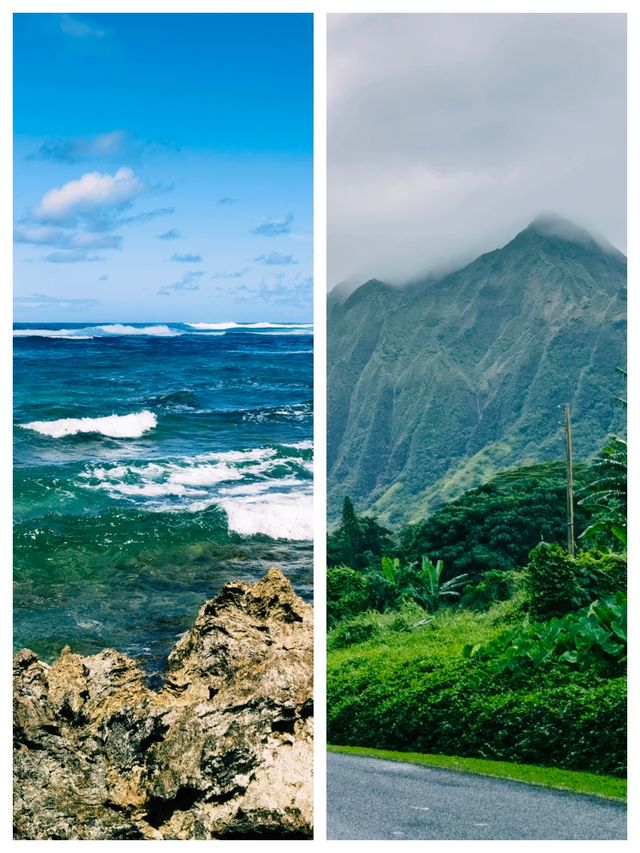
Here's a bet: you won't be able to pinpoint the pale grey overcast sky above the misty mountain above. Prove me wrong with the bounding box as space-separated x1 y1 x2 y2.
328 14 626 287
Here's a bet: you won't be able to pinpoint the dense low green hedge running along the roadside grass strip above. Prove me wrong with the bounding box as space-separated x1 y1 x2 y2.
327 635 626 775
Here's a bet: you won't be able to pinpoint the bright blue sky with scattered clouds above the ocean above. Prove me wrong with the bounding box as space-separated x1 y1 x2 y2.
14 14 313 322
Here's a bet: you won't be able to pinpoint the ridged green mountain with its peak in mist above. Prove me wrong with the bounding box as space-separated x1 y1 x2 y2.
327 216 626 524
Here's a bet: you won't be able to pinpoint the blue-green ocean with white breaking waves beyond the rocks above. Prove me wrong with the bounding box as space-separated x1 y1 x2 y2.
14 323 313 676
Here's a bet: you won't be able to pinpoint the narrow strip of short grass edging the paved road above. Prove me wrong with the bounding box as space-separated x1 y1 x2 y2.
328 745 627 801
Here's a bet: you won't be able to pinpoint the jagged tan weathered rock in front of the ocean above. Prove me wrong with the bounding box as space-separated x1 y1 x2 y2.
14 569 313 839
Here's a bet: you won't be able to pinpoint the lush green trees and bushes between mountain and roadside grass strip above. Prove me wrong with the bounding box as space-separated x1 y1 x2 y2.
327 440 627 790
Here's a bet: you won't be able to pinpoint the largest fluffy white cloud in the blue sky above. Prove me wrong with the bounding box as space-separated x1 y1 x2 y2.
33 167 145 223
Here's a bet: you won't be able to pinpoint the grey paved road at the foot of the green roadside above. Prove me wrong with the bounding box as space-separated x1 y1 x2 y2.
327 753 627 840
